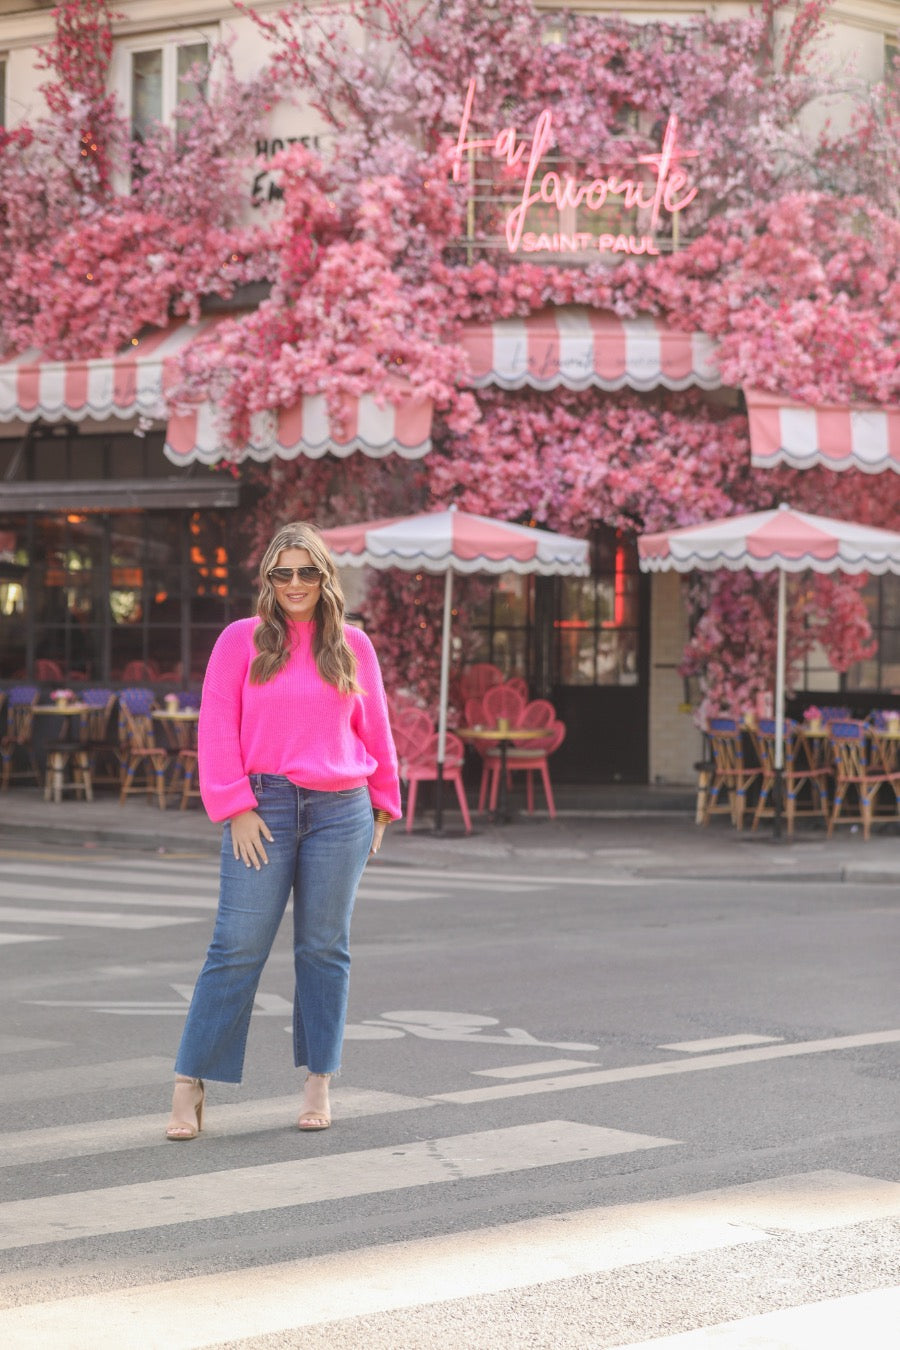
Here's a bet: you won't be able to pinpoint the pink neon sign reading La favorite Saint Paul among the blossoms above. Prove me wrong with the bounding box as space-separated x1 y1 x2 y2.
453 80 698 252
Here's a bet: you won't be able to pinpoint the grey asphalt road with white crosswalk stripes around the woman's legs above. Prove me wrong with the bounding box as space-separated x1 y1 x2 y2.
0 842 900 1350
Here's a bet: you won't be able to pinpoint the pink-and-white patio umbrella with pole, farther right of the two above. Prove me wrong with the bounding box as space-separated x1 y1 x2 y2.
638 505 900 828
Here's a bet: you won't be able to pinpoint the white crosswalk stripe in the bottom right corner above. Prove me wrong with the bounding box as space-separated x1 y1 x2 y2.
614 1288 900 1350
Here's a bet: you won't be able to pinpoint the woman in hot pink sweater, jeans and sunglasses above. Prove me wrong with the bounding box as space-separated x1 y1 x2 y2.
166 522 399 1139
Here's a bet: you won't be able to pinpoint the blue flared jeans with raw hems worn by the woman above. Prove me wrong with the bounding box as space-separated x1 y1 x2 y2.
175 774 372 1083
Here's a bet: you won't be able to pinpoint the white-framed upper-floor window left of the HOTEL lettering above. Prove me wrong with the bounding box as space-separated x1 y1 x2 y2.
116 32 213 140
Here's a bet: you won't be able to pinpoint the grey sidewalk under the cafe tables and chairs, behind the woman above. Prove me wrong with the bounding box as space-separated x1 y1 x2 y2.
0 786 900 886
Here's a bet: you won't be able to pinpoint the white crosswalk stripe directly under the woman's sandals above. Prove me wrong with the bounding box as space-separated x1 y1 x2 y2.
0 1085 436 1168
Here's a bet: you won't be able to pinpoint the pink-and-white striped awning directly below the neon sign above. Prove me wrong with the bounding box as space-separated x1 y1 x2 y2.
460 305 722 392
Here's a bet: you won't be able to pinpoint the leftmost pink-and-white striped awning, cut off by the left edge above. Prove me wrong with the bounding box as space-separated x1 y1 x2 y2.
0 319 215 423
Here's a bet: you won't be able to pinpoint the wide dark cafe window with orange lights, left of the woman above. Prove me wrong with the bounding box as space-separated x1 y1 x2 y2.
0 509 254 687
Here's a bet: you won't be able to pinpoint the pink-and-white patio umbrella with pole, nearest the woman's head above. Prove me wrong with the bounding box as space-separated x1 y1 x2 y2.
322 506 591 830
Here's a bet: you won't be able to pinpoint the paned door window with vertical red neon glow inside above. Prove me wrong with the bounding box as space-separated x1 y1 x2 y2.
553 529 640 686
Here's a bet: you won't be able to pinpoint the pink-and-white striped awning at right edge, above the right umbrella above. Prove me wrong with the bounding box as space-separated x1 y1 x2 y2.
743 389 900 474
